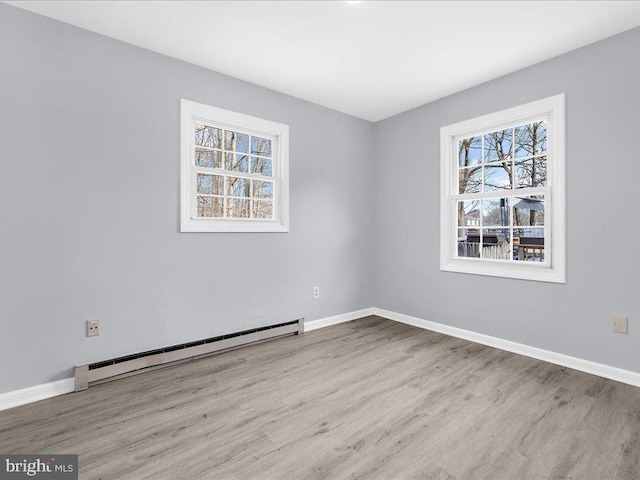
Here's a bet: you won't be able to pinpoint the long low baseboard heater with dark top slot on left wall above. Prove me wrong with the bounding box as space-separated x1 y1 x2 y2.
75 318 304 392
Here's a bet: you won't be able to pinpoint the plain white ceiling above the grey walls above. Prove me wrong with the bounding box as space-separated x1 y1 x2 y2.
6 0 640 121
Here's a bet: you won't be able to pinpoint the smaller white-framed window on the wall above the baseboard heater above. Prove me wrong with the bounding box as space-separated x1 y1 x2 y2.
180 100 289 232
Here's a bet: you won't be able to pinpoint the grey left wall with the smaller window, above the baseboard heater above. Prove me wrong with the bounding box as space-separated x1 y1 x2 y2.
0 4 374 393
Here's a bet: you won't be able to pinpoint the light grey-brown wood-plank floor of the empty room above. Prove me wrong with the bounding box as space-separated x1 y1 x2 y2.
0 317 640 480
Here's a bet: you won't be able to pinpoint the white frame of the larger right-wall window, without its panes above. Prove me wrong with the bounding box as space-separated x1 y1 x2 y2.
440 94 566 283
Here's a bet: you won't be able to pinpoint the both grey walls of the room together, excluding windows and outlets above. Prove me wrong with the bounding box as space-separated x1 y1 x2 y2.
0 4 640 393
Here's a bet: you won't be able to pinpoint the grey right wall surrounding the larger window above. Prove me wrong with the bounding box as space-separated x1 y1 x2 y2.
375 25 640 372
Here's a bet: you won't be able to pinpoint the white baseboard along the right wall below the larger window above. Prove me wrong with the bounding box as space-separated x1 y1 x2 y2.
373 308 640 387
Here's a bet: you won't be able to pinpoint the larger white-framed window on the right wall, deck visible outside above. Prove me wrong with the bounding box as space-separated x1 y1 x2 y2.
440 95 565 283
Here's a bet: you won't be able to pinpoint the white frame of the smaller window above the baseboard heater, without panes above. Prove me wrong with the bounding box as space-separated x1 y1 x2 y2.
180 99 289 232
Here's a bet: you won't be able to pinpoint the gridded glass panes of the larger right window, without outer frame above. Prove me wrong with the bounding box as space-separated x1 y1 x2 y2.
456 119 549 263
